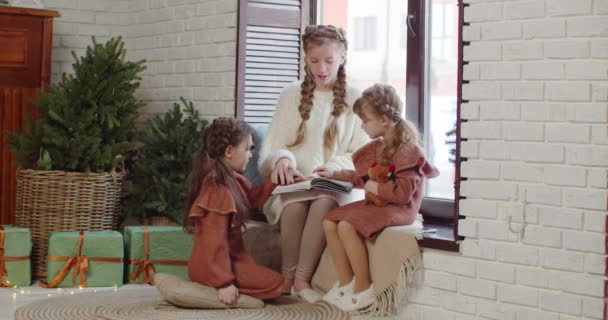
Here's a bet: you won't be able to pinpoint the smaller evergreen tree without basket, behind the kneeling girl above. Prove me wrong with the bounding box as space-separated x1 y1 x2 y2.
125 98 208 224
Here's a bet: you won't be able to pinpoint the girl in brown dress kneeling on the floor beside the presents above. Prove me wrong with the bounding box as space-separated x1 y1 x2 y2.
184 118 297 304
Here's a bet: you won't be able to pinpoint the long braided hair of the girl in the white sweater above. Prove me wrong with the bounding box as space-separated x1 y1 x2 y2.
288 25 348 152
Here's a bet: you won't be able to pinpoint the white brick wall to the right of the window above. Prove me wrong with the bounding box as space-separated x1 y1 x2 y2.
403 0 608 320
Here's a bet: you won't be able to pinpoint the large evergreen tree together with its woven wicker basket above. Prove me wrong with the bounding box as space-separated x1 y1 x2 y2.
7 37 145 277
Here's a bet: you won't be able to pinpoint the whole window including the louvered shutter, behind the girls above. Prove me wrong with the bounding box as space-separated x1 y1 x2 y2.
236 0 463 251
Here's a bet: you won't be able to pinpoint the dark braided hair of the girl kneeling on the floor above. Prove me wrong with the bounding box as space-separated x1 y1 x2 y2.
182 118 252 232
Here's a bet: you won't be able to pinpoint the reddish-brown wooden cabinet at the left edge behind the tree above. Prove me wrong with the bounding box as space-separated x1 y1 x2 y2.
0 6 59 224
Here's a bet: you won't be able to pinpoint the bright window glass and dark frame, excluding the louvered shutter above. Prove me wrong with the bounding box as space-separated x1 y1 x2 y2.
317 0 461 250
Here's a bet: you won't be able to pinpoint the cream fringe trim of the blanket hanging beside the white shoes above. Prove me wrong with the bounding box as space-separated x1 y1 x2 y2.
359 253 424 317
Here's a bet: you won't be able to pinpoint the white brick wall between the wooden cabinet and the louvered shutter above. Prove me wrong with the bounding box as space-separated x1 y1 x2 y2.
34 0 238 117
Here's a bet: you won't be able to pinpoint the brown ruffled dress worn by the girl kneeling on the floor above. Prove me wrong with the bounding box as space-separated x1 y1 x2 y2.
188 173 284 299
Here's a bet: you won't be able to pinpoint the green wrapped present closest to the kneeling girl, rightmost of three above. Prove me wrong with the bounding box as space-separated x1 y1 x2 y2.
125 226 193 284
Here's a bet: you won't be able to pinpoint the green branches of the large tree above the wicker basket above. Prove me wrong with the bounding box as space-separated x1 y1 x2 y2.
9 37 145 172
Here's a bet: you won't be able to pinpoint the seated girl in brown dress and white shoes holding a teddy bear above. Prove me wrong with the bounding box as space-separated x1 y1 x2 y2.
315 84 438 311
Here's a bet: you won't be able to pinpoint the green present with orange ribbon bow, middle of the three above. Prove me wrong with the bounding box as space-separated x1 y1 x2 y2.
40 231 124 288
